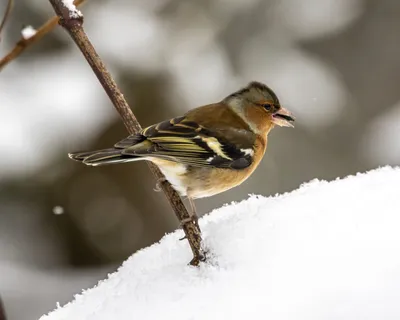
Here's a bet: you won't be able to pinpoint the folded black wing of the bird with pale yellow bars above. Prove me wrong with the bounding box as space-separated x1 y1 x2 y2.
115 111 255 169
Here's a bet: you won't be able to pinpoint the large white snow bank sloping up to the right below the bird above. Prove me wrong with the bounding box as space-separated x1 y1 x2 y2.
41 167 400 320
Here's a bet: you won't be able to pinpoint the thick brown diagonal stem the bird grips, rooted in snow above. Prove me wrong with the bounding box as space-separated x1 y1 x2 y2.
49 0 205 266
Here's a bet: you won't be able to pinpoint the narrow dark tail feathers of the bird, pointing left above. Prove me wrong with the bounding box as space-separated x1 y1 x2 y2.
68 148 144 166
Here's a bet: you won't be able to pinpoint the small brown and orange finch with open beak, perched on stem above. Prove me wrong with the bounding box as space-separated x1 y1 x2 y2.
69 81 295 222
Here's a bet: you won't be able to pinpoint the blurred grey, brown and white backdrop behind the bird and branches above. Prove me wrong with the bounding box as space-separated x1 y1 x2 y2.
0 0 400 320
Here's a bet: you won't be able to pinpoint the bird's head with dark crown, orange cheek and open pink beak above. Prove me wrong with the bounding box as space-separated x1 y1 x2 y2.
225 81 295 132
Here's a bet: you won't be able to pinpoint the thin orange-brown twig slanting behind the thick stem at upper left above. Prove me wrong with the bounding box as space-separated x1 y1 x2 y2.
0 0 85 71
